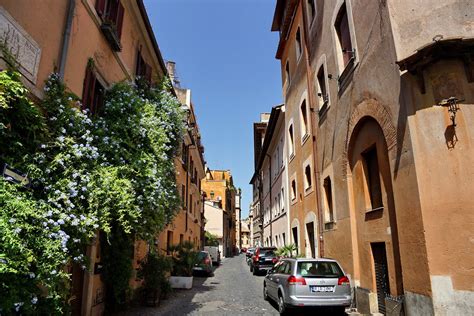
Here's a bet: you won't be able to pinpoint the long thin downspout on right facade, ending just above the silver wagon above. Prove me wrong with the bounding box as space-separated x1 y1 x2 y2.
301 0 324 257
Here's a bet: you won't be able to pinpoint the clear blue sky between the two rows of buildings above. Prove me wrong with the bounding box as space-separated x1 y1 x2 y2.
145 0 282 218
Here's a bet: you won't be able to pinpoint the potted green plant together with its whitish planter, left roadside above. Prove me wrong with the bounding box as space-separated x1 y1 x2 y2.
169 241 198 289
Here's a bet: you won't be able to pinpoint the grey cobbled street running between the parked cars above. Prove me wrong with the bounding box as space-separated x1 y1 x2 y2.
120 255 278 316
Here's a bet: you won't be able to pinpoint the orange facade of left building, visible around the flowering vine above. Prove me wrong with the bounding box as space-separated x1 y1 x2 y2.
0 0 204 315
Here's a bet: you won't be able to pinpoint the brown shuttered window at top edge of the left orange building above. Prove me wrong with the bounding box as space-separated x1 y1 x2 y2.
95 0 124 51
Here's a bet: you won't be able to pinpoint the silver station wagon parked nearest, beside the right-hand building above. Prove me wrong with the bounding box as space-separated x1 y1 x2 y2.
263 258 351 315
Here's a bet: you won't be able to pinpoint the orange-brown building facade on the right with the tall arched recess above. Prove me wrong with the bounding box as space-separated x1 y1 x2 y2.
272 0 474 315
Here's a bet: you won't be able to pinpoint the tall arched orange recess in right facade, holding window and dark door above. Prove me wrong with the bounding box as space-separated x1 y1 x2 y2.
347 116 403 313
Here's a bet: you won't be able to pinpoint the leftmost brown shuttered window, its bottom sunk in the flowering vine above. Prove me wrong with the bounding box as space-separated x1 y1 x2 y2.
82 65 105 114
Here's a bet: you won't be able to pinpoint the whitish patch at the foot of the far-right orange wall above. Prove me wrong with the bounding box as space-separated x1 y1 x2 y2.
431 276 474 316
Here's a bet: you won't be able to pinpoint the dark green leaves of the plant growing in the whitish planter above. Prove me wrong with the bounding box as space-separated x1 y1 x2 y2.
169 241 199 276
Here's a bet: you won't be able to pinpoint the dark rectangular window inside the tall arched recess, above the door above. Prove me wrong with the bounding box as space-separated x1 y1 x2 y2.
362 146 383 210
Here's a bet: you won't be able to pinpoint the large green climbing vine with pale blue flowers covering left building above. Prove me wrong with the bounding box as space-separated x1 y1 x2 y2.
0 71 184 313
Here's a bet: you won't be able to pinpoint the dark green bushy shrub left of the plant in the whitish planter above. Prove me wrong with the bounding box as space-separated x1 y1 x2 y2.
137 252 173 306
